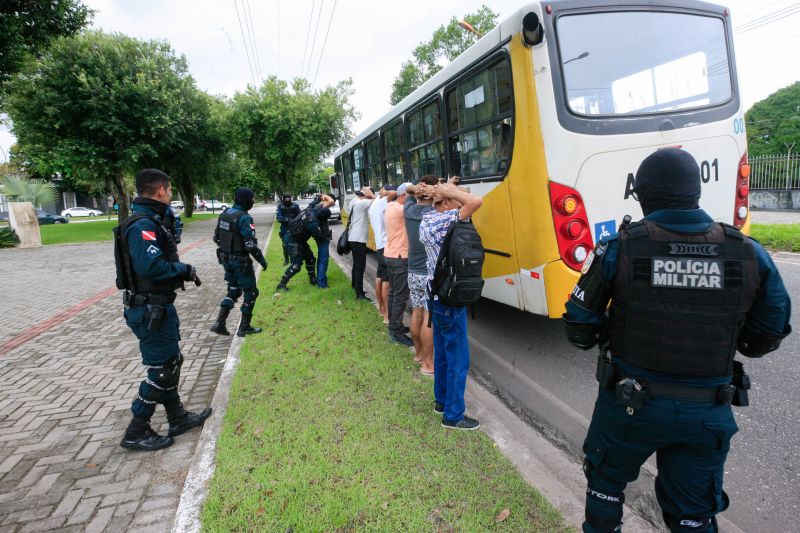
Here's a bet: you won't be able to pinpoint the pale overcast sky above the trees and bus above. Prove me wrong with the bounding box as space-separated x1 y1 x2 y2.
0 0 800 160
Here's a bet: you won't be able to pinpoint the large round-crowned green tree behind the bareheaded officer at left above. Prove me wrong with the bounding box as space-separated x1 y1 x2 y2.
7 32 205 220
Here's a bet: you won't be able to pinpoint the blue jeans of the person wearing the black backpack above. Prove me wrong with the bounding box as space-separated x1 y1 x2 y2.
431 300 469 422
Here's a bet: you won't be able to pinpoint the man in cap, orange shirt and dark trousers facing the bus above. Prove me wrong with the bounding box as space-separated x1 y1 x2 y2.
383 183 414 346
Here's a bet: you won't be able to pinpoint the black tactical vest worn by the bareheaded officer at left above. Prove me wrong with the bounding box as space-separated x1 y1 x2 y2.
114 213 183 294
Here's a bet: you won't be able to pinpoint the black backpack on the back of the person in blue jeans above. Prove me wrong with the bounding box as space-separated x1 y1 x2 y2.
431 220 485 307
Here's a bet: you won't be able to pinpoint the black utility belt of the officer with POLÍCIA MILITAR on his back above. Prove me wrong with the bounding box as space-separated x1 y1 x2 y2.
596 353 750 413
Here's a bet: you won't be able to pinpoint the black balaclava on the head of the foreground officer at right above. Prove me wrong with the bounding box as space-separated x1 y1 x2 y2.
633 148 700 215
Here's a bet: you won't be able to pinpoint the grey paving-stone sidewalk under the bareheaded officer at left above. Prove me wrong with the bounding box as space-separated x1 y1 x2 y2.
0 207 274 533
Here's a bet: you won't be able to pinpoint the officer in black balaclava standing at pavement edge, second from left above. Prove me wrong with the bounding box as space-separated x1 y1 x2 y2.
211 188 267 337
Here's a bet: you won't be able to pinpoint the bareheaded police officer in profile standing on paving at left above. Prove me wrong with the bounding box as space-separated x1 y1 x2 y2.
115 169 211 450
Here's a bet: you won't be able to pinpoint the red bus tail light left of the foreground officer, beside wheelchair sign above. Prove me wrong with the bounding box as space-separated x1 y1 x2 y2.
550 181 594 270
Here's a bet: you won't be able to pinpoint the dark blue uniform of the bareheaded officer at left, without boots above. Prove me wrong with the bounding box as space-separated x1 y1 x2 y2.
124 198 191 420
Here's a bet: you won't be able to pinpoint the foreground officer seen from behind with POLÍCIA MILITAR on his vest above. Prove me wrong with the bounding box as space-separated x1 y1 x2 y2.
564 148 791 532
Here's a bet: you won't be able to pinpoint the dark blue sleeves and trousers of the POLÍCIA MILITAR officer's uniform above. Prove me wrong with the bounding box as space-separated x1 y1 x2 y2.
564 209 791 532
